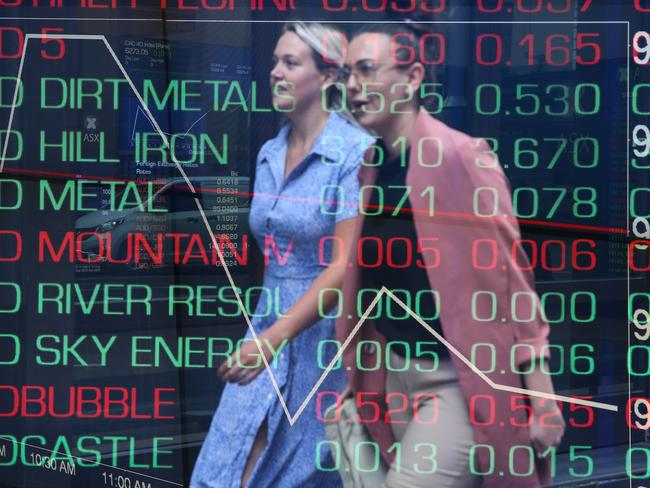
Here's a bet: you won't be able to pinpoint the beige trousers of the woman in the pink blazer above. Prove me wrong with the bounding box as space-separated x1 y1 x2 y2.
383 353 480 488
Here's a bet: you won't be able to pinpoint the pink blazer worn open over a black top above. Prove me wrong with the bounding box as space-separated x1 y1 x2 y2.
336 108 551 488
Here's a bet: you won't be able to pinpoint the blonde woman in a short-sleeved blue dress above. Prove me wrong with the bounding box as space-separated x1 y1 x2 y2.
191 23 372 488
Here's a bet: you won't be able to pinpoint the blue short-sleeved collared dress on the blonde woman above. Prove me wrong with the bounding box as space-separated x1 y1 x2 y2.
190 113 372 488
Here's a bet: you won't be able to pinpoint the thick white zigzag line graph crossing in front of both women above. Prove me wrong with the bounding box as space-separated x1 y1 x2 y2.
0 34 618 446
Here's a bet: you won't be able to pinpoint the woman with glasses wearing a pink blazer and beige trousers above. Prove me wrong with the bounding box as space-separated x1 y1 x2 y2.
336 24 565 488
